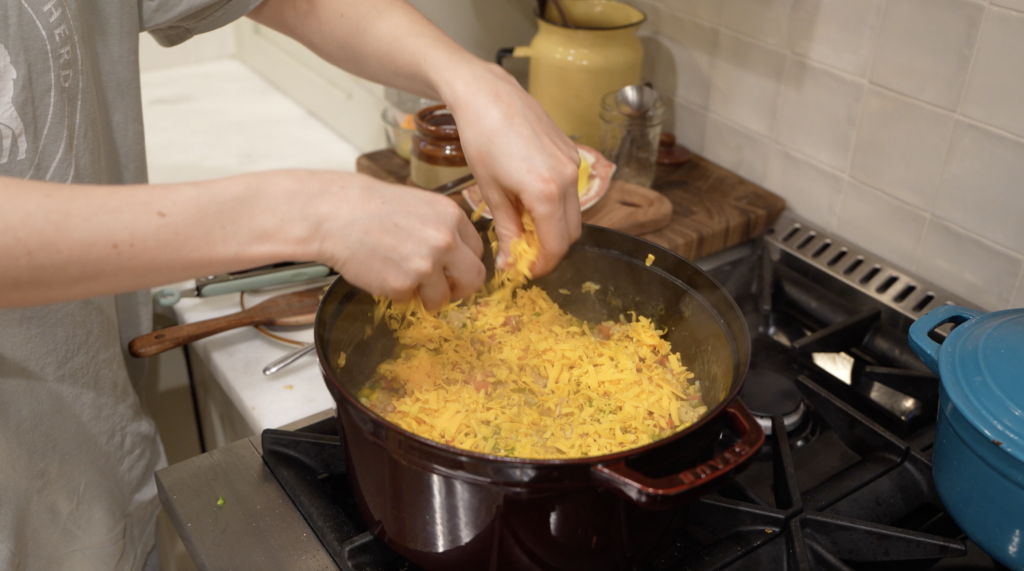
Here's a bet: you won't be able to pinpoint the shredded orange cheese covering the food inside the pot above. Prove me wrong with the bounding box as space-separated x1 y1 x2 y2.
357 215 708 458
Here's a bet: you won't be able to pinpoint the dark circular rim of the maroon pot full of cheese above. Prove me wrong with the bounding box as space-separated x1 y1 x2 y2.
313 223 751 467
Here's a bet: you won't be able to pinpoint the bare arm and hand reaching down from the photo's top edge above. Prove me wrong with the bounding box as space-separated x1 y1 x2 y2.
249 0 581 273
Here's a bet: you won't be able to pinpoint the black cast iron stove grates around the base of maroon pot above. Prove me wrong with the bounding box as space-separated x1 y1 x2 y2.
262 360 999 571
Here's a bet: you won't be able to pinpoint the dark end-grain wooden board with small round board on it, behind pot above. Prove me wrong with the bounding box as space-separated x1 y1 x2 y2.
356 150 785 260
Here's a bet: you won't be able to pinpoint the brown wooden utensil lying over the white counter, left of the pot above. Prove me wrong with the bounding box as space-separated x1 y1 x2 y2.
128 288 324 357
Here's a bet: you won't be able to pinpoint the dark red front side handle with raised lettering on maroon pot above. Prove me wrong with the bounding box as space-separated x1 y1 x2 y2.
591 399 765 504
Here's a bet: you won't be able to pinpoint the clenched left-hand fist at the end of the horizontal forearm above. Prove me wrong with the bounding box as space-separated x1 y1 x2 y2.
310 172 485 310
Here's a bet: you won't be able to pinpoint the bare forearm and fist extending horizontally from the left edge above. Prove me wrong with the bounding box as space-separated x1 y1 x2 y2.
0 171 484 307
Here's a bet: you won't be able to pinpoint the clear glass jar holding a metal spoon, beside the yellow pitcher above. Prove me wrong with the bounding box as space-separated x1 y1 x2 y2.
598 91 665 187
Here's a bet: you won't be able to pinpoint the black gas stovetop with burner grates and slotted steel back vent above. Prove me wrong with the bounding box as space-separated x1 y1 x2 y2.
158 213 1004 571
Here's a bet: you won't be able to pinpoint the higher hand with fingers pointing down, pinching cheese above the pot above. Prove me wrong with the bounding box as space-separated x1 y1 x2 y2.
441 59 582 275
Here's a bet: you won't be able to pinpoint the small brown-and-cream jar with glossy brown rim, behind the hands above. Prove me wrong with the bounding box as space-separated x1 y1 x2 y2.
409 105 469 188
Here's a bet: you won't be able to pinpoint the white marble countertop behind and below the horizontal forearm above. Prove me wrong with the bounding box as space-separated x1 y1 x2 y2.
142 59 359 434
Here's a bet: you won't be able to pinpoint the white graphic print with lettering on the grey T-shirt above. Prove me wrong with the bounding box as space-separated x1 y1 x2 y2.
0 0 82 182
